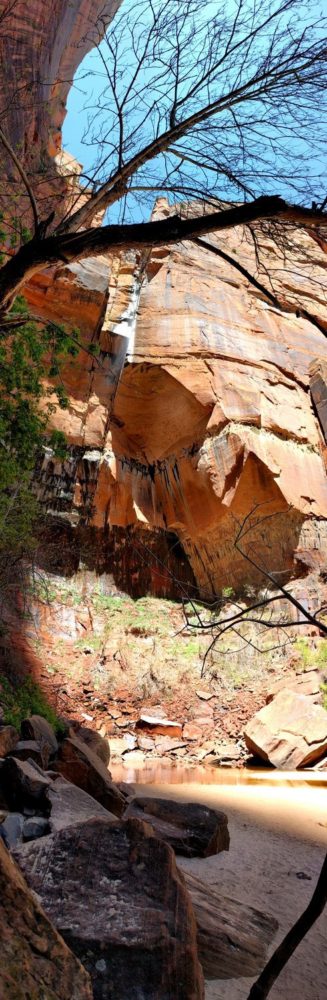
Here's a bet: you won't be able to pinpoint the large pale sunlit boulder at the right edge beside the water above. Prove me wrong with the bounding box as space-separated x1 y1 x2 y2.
244 690 327 770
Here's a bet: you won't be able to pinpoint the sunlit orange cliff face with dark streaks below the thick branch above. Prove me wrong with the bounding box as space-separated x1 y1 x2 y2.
28 202 327 595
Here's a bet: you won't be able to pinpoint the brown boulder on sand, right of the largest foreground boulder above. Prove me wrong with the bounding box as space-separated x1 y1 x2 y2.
183 871 278 979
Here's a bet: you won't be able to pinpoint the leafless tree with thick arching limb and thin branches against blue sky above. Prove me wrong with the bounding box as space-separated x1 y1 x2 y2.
0 0 327 318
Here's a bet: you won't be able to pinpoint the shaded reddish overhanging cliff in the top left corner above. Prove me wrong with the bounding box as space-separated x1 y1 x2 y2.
0 0 120 218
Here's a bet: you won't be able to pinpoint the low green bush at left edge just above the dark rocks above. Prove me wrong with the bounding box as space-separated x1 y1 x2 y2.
0 674 65 734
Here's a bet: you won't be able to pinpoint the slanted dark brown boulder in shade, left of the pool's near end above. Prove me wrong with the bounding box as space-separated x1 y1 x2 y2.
56 736 125 816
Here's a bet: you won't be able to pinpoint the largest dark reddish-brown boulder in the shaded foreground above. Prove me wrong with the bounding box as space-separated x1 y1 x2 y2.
15 819 204 1000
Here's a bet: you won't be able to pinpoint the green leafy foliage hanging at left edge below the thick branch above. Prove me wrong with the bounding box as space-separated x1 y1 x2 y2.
0 292 80 568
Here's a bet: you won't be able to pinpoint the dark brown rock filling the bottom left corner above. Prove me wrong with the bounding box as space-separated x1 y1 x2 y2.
0 839 93 1000
